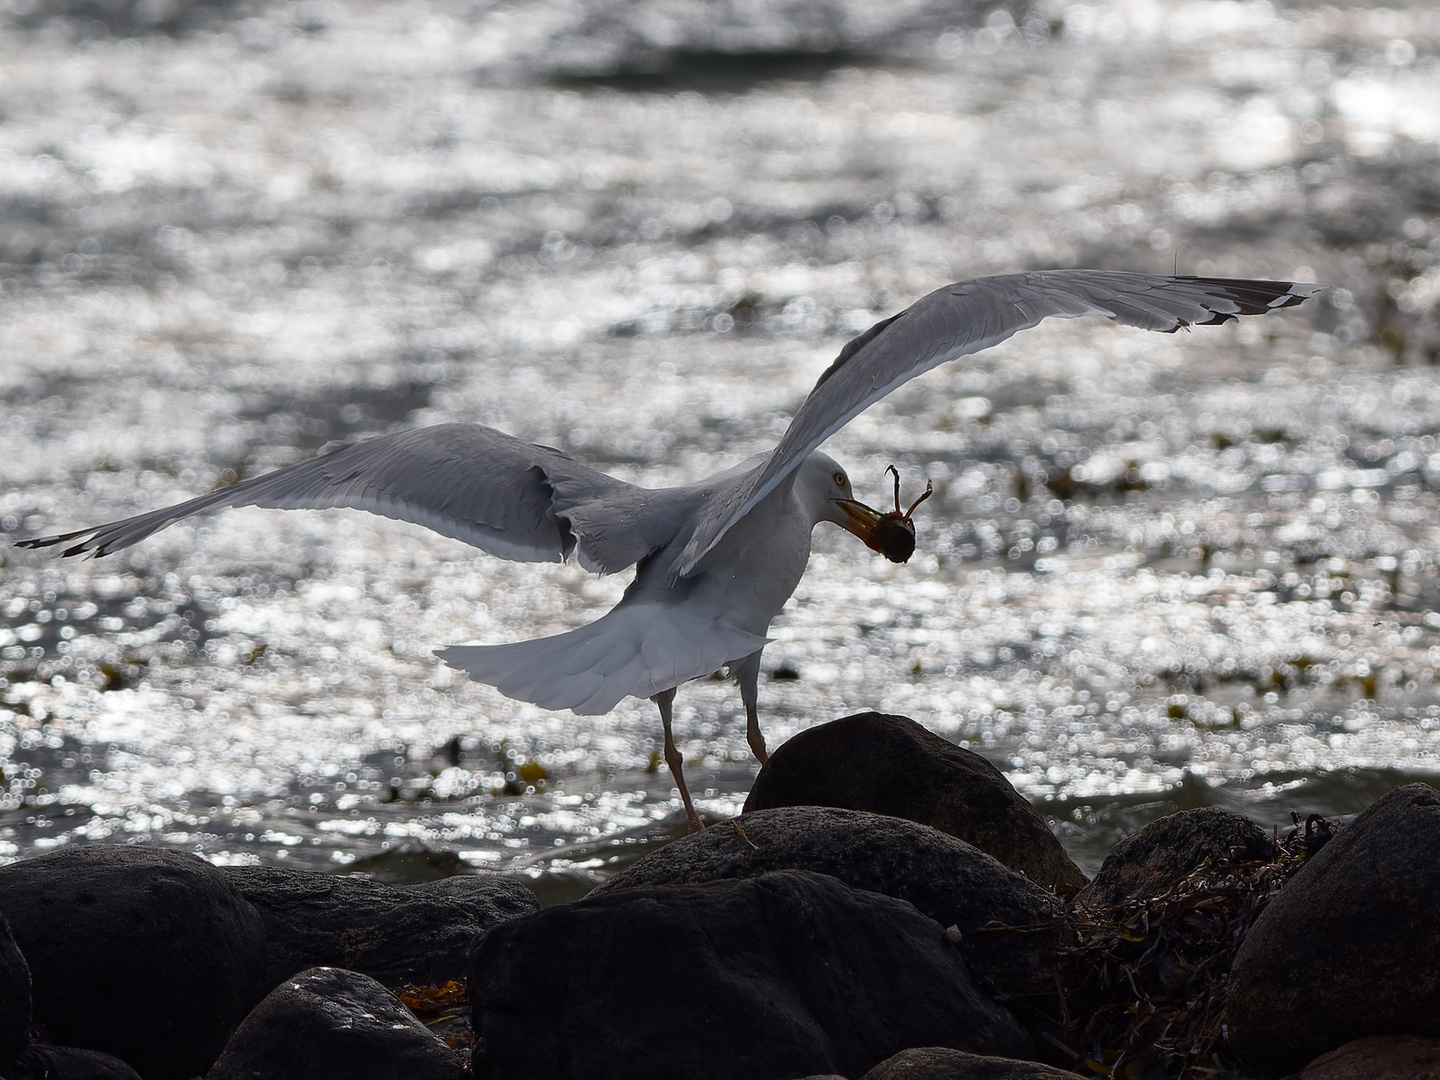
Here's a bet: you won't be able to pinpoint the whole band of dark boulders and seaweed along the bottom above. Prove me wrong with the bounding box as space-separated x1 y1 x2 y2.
0 713 1440 1080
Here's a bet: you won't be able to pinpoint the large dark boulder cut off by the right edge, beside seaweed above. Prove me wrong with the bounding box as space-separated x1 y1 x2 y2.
1225 783 1440 1074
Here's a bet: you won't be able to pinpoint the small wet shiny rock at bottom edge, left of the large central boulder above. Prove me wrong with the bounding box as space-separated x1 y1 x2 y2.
207 968 467 1080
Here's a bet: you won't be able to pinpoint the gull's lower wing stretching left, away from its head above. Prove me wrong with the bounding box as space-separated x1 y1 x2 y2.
20 423 668 573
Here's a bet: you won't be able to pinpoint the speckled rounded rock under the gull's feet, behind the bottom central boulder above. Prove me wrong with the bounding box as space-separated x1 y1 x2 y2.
590 806 1061 994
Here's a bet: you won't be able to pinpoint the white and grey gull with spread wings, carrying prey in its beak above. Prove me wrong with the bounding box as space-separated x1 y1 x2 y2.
19 269 1323 832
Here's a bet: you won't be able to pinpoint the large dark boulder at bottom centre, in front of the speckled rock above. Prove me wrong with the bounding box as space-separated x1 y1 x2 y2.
471 870 1032 1080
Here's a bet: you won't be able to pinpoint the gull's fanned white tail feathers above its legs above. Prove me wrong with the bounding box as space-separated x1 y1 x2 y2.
435 603 768 716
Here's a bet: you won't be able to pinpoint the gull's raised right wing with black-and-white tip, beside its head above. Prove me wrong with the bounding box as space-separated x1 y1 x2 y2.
674 269 1325 575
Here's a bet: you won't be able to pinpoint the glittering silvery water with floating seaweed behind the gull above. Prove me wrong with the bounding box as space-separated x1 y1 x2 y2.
0 0 1440 899
